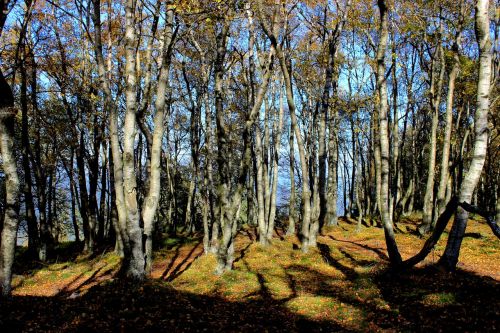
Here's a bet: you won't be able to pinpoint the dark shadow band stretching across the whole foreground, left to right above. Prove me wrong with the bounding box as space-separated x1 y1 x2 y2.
0 256 500 332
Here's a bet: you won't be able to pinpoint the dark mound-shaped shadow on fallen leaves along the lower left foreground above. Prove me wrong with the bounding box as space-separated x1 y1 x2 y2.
0 280 350 332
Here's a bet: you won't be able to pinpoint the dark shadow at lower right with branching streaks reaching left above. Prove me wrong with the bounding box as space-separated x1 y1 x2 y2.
310 244 500 332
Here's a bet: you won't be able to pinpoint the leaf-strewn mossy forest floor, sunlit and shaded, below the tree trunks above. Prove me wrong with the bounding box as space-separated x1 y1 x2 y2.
0 218 500 332
